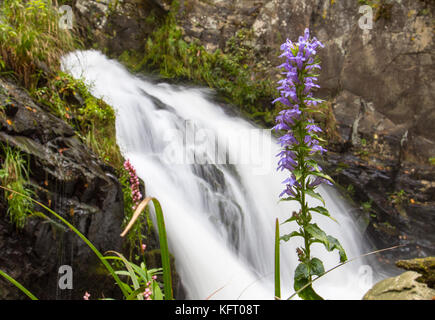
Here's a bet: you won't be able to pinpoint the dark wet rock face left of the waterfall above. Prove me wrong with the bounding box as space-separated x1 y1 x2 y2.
0 80 124 299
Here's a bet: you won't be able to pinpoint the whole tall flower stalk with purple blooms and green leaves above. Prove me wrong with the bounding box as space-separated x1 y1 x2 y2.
273 29 347 300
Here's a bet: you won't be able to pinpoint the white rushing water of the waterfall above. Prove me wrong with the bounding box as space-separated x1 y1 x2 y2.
62 51 373 299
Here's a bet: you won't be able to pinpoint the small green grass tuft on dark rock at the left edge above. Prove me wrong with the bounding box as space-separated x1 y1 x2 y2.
0 146 33 229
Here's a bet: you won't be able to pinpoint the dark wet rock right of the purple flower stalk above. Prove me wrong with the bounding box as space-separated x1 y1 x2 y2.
323 150 435 267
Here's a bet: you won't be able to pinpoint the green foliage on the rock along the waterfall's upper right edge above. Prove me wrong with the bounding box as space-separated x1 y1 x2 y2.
119 10 276 123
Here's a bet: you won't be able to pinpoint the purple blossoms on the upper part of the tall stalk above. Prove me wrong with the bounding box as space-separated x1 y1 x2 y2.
273 29 331 197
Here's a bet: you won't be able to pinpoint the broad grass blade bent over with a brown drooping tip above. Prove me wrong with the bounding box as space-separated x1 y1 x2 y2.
121 197 173 300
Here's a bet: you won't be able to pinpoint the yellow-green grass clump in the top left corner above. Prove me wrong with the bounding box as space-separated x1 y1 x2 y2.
0 0 74 88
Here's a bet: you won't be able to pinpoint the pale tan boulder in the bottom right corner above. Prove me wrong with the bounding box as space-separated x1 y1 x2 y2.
363 271 435 300
